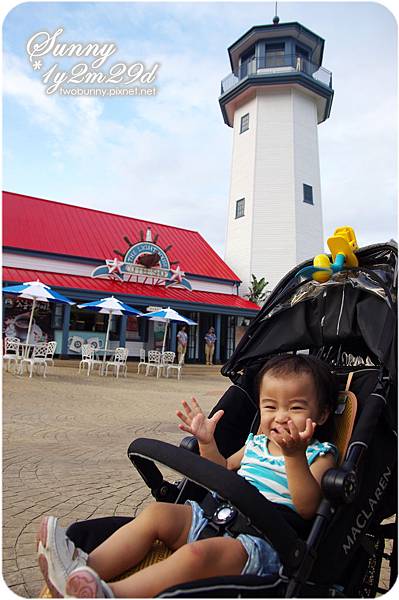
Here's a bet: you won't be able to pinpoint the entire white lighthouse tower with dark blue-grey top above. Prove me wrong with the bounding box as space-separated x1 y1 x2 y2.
219 17 334 294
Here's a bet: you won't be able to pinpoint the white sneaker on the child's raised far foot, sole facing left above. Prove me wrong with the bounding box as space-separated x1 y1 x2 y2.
37 517 88 598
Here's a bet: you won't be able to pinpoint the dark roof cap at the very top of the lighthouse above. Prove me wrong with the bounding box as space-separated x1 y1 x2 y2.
228 21 324 73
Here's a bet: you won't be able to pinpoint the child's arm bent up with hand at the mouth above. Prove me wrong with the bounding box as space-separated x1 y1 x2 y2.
270 419 335 519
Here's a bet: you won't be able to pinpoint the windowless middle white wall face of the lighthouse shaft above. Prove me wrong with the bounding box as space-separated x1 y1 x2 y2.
251 87 296 289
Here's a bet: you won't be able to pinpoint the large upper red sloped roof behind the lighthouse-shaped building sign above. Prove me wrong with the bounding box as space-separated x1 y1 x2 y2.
3 192 240 281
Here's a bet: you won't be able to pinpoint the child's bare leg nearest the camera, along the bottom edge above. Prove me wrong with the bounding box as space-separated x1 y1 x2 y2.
67 537 248 598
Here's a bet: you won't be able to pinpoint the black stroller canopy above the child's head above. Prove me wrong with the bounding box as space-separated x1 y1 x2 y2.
222 242 397 381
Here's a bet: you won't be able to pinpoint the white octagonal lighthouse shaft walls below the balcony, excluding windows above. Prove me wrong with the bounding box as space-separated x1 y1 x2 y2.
225 85 322 295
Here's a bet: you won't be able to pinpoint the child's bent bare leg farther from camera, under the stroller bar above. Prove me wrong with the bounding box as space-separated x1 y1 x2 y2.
87 502 191 581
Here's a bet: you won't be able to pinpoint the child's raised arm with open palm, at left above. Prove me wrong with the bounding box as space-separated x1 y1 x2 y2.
176 398 244 469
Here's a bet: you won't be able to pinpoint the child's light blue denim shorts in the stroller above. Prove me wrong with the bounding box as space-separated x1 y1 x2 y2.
186 500 281 575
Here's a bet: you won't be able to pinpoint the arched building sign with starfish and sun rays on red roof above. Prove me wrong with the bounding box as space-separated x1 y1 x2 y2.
91 227 192 290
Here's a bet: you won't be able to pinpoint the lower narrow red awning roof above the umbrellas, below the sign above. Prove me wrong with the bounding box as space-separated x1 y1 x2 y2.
3 267 259 310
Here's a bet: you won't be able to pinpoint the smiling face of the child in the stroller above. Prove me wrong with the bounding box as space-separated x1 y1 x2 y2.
259 373 328 436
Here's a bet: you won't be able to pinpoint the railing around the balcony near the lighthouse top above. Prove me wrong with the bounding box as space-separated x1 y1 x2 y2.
221 54 332 94
